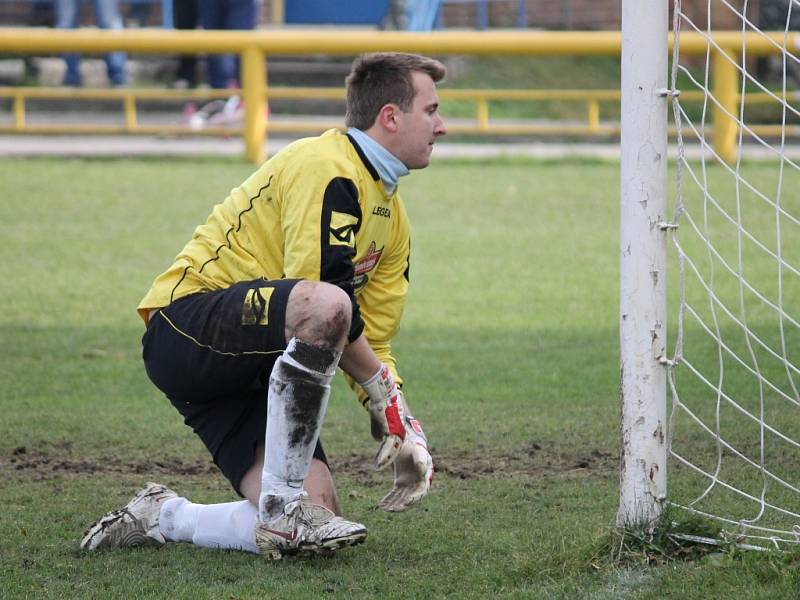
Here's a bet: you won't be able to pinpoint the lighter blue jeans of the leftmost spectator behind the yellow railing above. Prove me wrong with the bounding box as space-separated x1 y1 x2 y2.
55 0 128 85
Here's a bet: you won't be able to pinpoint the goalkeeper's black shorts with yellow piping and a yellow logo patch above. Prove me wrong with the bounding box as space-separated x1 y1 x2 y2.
142 279 328 495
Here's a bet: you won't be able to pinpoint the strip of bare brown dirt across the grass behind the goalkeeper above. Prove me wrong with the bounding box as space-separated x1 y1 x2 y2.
0 443 619 483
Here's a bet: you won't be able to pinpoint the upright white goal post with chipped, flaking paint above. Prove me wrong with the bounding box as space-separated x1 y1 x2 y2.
617 0 668 526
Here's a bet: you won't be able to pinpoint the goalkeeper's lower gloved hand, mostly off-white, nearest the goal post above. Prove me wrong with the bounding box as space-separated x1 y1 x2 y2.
378 416 433 512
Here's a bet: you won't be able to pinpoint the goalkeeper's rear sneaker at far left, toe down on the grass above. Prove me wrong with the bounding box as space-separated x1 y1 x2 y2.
81 482 178 550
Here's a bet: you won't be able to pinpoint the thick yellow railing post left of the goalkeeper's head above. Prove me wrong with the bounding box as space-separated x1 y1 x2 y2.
242 46 267 164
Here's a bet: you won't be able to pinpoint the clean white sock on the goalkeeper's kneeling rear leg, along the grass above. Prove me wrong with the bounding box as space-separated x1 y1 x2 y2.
158 498 258 554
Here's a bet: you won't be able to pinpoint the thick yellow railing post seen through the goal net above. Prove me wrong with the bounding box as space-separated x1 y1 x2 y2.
714 50 739 163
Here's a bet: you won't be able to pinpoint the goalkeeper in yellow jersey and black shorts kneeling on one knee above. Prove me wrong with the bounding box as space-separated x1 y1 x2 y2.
81 53 446 559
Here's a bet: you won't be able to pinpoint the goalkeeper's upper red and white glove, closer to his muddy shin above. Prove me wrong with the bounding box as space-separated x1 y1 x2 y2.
361 365 406 471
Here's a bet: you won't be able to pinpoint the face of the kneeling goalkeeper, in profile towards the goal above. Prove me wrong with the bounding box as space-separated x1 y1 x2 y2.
391 71 447 169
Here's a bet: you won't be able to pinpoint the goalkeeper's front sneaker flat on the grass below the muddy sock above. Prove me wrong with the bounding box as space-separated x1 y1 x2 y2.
256 495 367 560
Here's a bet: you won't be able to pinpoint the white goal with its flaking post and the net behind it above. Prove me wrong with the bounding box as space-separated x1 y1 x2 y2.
617 0 800 548
